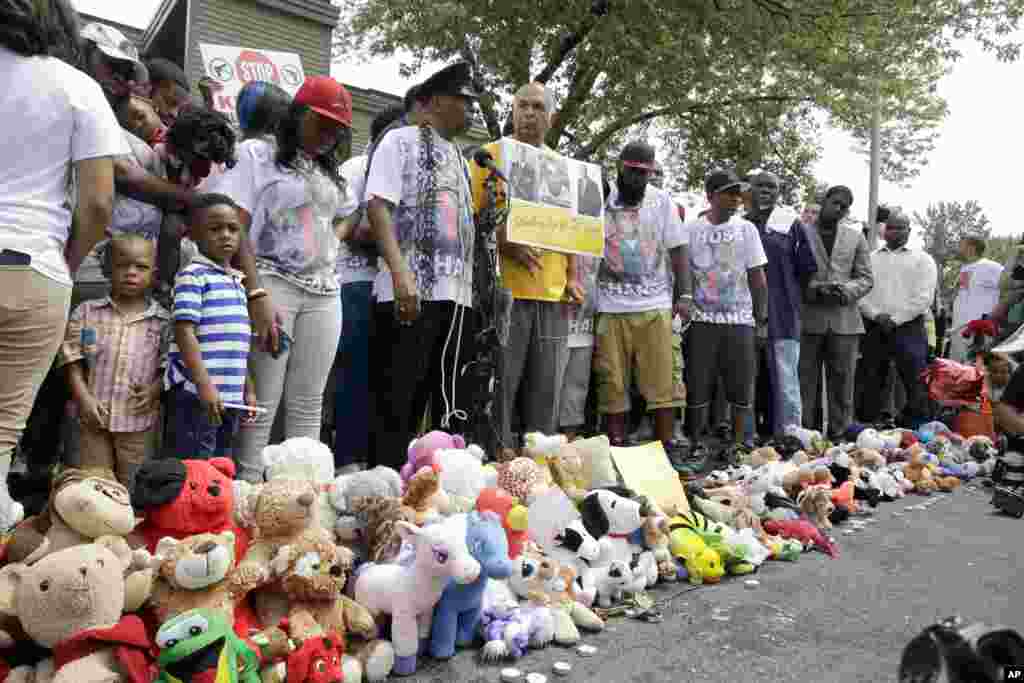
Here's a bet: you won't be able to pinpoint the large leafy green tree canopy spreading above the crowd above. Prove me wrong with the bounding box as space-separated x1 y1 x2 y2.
335 0 1024 194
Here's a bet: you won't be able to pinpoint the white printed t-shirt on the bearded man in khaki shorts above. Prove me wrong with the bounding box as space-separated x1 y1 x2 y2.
597 183 687 313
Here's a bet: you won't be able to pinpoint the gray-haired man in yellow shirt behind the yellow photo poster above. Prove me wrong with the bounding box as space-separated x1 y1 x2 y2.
470 83 583 447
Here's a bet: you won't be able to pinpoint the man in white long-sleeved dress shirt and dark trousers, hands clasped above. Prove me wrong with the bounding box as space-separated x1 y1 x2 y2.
860 213 937 429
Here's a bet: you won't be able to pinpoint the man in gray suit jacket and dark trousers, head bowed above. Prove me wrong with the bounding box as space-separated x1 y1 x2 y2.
800 185 874 437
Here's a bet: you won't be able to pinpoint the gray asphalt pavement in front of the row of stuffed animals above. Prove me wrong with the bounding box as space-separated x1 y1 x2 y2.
397 486 1024 683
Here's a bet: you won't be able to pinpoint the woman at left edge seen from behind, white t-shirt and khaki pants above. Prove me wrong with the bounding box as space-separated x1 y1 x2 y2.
0 0 126 528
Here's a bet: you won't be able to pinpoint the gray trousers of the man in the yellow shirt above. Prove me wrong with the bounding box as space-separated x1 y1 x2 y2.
502 299 569 445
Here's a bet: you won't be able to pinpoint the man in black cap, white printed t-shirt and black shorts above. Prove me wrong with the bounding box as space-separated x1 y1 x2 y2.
681 169 768 475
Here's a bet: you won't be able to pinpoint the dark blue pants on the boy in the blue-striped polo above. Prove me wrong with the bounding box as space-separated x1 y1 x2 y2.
164 384 241 460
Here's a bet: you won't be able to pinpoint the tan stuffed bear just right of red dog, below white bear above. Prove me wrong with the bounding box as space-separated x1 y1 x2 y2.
236 479 321 590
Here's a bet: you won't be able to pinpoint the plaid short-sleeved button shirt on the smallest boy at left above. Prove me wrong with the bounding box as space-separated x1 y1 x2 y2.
57 297 170 432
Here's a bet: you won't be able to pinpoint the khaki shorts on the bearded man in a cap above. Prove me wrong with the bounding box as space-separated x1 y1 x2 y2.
594 309 684 415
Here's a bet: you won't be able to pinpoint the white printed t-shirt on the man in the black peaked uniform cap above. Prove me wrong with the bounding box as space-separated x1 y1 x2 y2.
366 126 475 306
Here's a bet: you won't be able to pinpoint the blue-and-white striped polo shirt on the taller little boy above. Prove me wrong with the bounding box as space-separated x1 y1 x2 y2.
164 254 252 403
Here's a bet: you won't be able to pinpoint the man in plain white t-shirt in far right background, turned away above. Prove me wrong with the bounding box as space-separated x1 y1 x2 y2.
949 234 1002 362
